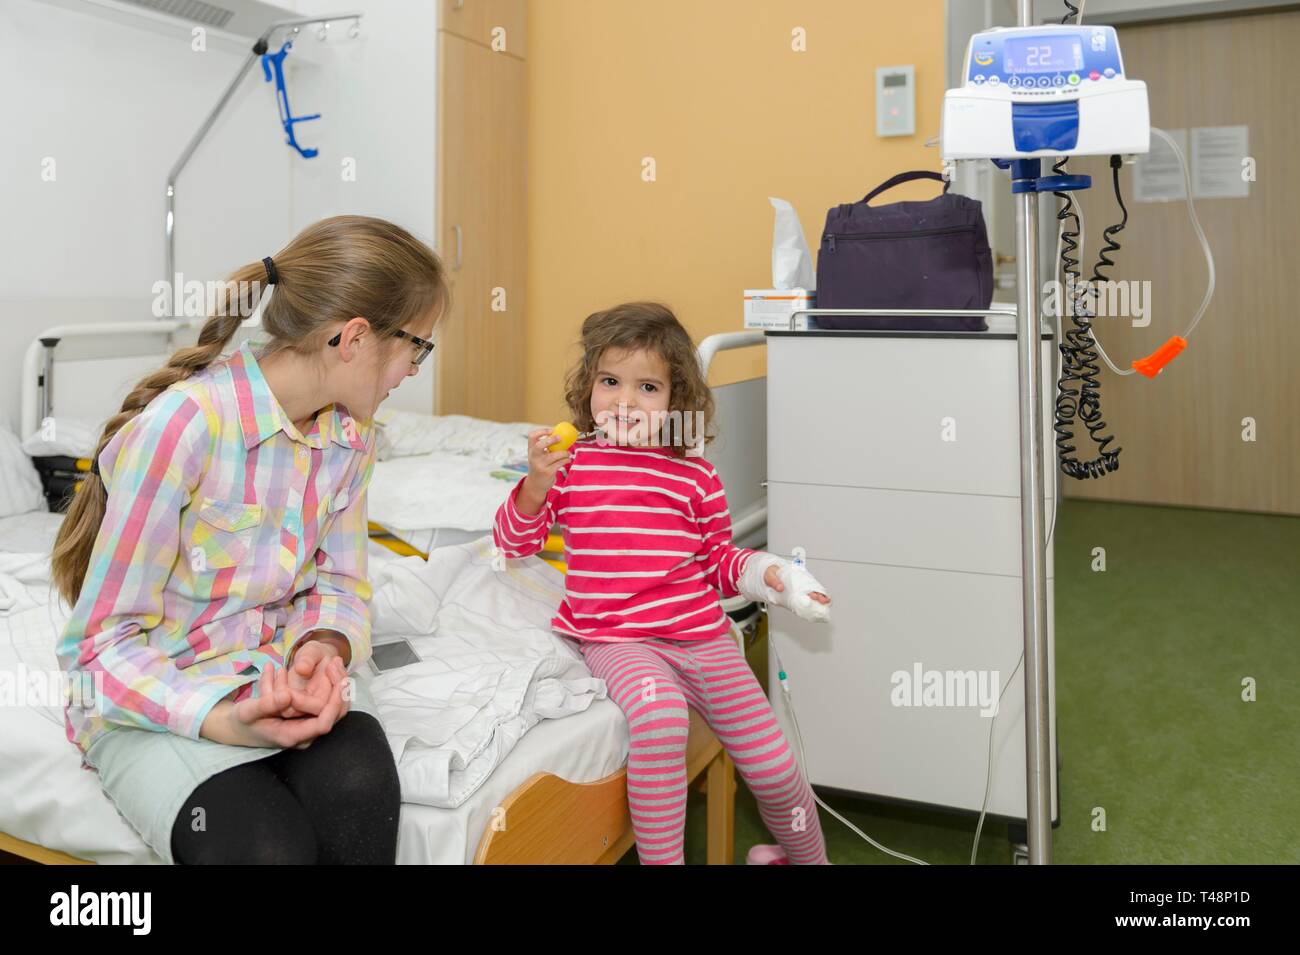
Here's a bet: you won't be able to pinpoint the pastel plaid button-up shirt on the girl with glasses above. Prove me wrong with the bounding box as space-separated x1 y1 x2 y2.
57 343 376 752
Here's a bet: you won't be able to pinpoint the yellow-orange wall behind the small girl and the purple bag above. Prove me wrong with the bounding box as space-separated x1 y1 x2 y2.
525 0 944 421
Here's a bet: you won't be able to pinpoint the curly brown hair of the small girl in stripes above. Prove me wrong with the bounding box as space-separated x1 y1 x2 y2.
564 301 715 457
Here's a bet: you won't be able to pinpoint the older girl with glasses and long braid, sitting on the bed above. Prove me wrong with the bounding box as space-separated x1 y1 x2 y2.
52 216 447 863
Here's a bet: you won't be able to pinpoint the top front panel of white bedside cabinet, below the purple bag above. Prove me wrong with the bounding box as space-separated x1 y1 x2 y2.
767 335 1050 496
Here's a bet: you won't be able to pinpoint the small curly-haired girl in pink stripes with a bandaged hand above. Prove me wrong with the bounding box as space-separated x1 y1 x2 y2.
494 303 831 864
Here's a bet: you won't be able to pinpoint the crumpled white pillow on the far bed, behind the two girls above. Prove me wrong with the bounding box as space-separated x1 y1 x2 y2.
374 408 545 463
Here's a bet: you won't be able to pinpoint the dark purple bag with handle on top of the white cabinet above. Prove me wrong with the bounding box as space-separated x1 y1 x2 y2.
816 170 993 331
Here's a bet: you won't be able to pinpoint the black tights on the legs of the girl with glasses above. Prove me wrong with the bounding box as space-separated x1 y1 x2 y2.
172 711 402 865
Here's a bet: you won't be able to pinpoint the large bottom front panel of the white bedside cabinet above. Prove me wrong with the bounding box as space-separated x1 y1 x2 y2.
768 560 1058 817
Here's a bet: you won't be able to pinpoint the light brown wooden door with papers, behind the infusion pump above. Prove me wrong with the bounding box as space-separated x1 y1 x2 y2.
1060 10 1300 515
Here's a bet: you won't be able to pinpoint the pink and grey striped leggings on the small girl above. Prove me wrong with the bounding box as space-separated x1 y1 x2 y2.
581 635 827 865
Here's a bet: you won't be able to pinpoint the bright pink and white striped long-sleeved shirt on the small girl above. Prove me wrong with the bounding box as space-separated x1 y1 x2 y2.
493 442 754 643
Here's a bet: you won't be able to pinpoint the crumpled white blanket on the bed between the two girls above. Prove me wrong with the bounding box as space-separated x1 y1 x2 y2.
369 537 606 808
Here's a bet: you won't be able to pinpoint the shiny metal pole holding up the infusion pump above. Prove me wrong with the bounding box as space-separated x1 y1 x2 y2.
1015 0 1052 865
